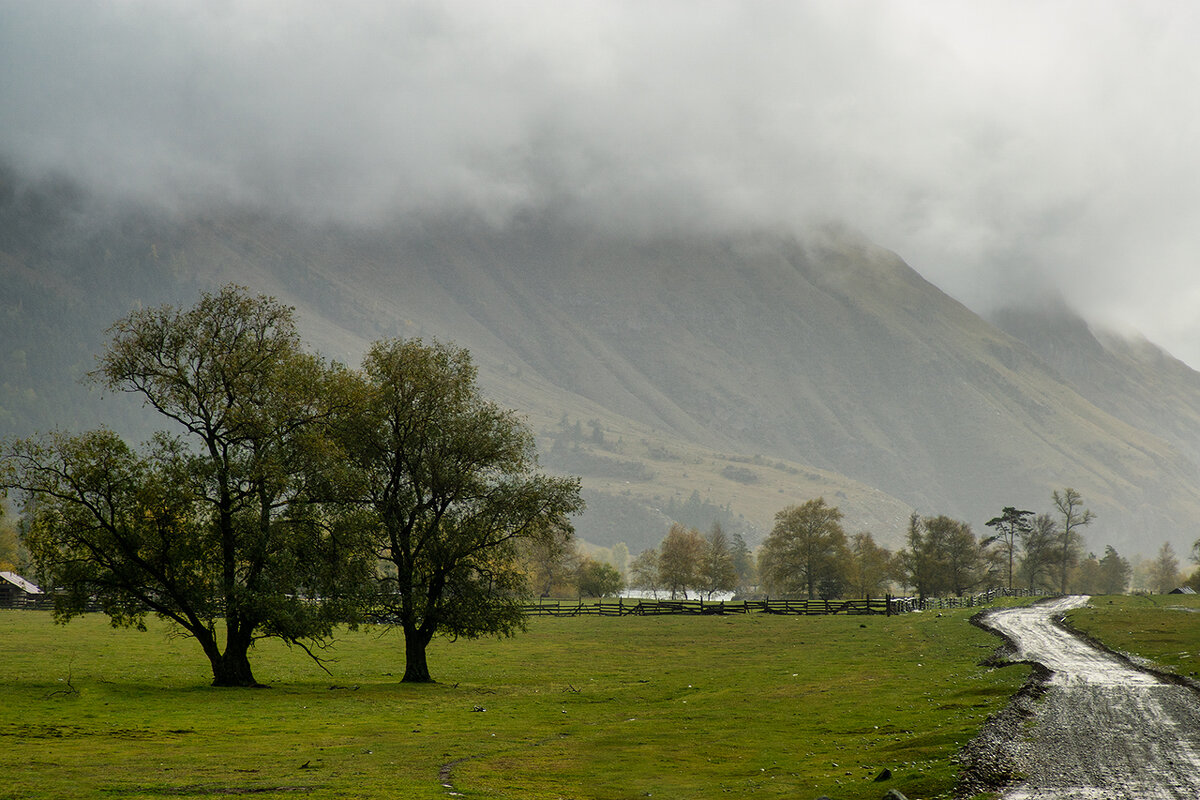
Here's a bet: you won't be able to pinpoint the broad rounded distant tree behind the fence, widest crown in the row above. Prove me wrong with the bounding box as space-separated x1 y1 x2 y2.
758 498 850 600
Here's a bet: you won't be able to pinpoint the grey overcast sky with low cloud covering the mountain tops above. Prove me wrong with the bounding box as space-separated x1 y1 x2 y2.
7 0 1200 366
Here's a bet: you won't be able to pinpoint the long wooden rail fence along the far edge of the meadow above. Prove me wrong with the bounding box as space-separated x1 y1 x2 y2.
524 589 1046 616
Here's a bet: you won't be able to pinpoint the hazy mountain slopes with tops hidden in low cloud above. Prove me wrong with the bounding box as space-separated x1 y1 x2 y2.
0 165 1200 553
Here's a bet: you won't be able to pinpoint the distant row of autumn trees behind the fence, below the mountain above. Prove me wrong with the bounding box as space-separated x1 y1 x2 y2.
629 488 1147 600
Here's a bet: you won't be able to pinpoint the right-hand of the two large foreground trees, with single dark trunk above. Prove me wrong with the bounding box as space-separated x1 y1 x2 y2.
342 339 583 682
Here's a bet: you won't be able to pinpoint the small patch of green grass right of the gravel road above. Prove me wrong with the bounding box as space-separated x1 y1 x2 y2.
1067 595 1200 678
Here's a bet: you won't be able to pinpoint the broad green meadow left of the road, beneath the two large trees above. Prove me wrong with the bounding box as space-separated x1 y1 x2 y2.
0 609 1027 800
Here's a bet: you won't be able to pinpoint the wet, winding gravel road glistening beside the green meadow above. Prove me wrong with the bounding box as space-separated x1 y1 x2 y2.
980 596 1200 800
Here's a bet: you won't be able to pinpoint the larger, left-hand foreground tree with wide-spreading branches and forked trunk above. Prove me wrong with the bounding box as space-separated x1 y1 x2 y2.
2 285 367 686
